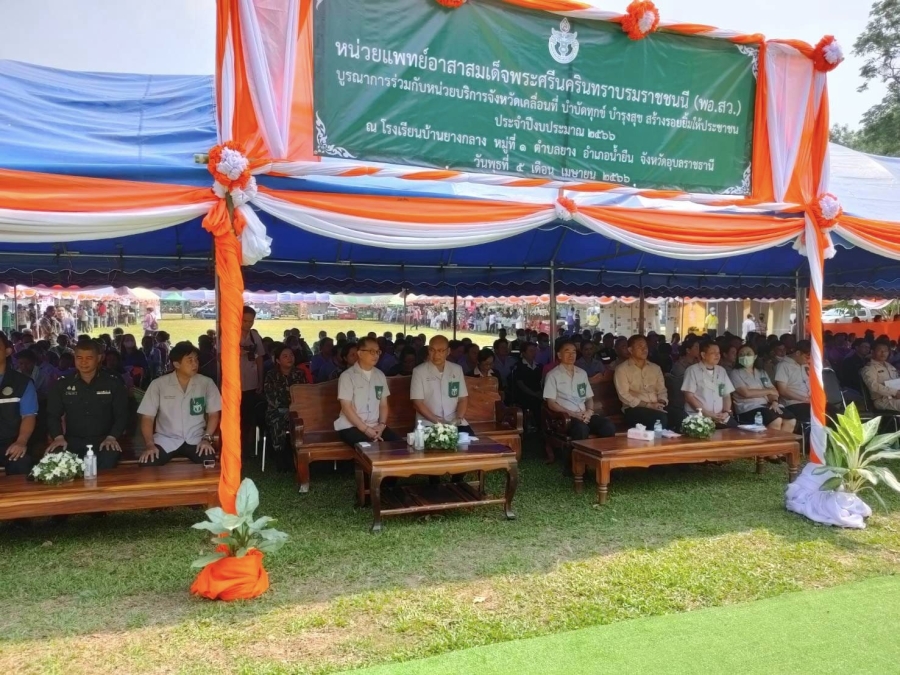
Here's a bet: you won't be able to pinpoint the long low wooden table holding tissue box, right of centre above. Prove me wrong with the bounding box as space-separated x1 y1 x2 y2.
572 429 800 504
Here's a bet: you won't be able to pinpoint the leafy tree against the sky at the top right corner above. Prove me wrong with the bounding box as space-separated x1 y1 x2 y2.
831 0 900 157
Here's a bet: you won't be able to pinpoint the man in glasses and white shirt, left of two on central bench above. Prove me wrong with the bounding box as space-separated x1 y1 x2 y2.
334 337 400 445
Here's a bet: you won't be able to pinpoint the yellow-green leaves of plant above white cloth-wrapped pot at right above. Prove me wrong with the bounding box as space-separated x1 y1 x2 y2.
813 403 900 506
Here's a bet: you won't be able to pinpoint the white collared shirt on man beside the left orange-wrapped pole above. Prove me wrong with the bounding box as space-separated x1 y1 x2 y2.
138 373 222 452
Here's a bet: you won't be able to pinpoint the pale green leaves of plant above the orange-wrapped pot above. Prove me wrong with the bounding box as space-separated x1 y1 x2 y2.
191 478 288 568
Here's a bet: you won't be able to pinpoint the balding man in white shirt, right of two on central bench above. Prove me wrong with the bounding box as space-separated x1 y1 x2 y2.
409 335 472 434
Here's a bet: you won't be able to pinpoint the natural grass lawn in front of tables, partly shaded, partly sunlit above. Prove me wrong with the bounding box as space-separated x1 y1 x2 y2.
0 445 900 675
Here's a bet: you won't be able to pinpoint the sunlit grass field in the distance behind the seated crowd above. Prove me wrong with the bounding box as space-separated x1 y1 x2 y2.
116 314 496 347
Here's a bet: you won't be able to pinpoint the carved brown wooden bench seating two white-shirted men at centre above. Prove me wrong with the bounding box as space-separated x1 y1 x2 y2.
290 376 522 492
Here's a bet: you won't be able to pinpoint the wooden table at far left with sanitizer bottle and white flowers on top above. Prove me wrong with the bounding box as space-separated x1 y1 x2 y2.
0 463 219 520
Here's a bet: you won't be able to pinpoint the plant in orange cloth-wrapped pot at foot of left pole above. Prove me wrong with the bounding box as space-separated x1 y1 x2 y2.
191 478 288 600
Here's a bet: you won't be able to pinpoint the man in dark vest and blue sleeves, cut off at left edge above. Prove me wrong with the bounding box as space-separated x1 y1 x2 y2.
0 333 38 476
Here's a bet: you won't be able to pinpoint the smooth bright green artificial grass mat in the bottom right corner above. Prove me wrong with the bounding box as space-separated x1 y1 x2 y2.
353 576 900 675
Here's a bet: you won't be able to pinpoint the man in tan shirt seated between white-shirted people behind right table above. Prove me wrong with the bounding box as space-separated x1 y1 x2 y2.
614 335 669 429
